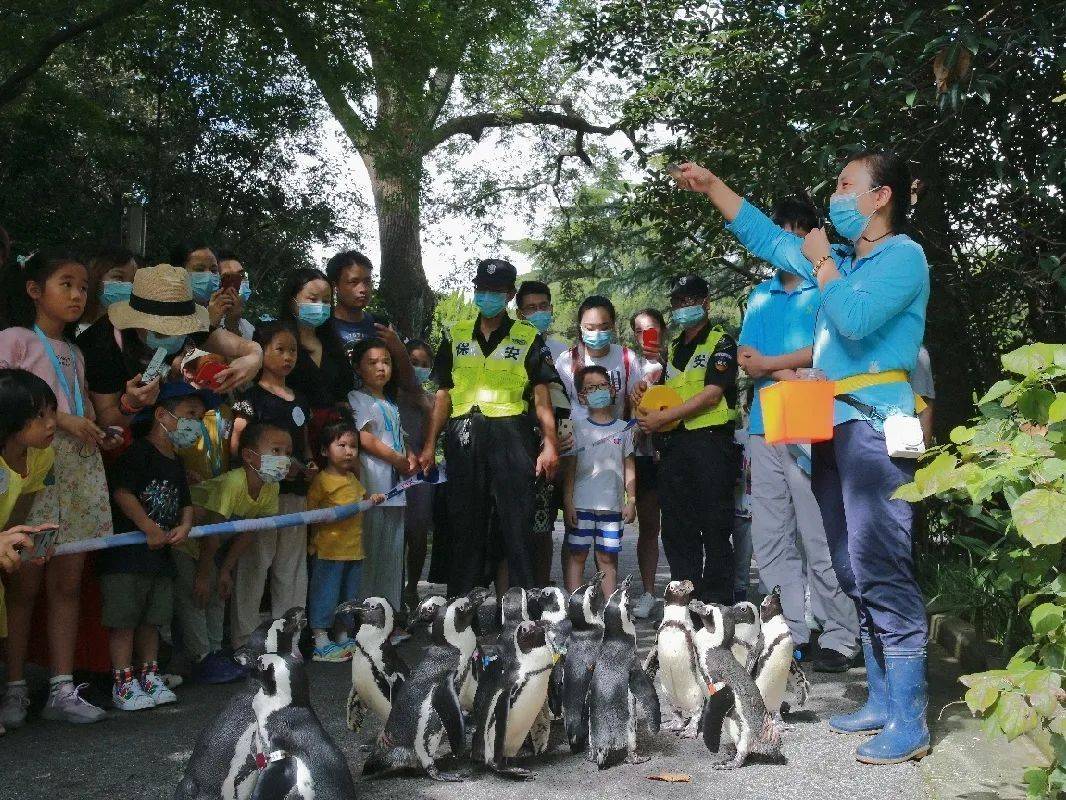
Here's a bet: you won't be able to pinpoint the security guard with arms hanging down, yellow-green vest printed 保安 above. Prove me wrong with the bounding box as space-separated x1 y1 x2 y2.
419 258 559 595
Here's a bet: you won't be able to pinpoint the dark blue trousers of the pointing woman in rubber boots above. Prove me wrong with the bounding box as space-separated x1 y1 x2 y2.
811 420 928 655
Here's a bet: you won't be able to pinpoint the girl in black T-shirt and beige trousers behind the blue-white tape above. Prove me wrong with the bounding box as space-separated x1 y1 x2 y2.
229 321 318 647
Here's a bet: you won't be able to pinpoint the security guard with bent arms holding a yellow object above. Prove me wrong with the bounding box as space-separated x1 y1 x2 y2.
634 275 740 605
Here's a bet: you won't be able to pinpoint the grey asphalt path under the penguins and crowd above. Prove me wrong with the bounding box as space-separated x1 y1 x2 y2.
0 528 930 800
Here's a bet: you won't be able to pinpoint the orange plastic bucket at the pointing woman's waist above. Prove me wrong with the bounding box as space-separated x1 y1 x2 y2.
759 381 836 445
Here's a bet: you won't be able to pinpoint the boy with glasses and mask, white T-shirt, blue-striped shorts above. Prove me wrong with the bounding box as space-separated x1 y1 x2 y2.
563 366 636 596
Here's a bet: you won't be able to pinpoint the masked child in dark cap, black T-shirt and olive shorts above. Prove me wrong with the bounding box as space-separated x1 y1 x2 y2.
96 383 205 711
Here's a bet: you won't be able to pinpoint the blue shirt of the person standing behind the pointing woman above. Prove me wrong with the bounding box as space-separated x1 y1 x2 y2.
737 273 821 435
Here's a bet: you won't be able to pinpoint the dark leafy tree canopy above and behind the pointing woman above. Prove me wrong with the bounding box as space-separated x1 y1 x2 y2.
570 0 1066 439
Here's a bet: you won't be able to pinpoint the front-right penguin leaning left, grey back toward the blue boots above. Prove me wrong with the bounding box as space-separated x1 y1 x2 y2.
689 601 780 769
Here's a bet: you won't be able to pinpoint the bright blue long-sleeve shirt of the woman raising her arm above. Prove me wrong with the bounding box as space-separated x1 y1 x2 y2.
726 201 930 428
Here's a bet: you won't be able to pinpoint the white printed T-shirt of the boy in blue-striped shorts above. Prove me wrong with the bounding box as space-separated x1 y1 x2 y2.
574 417 633 511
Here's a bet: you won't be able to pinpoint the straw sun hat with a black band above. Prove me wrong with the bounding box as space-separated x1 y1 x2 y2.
108 263 210 336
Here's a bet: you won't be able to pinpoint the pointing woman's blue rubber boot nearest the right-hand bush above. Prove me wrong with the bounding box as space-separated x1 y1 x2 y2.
855 651 930 764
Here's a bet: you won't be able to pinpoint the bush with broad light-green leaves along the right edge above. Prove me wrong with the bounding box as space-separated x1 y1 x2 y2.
897 343 1066 797
